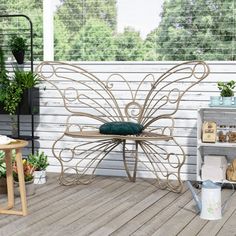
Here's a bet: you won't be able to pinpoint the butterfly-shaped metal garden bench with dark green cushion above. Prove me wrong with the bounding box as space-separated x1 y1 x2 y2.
37 61 209 192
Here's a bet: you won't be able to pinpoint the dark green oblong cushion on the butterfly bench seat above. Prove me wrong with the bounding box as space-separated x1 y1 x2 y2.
99 121 143 135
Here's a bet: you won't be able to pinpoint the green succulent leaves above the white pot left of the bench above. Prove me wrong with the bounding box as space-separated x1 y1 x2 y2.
28 151 49 171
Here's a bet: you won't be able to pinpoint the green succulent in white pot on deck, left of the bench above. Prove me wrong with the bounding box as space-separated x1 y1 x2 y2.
28 151 49 184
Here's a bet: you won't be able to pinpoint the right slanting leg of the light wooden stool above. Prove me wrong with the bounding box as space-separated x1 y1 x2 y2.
16 149 28 216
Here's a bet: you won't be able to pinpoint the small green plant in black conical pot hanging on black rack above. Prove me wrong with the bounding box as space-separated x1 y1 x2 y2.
10 35 27 64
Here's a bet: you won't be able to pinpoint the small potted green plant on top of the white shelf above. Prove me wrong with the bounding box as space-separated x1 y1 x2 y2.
217 80 235 106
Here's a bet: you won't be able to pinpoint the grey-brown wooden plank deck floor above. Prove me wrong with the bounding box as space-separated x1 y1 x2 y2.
0 174 236 236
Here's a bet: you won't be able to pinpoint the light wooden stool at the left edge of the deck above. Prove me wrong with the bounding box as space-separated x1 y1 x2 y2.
0 140 28 216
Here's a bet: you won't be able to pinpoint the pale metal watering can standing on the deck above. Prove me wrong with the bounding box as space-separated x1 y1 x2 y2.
187 180 234 220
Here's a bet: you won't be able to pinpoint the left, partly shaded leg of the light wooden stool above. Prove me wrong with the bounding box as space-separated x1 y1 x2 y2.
5 150 14 209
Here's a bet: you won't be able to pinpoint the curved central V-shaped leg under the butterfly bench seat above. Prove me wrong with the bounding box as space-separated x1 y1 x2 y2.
123 140 138 182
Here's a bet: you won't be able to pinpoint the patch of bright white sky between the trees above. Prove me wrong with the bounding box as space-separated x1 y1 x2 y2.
117 0 164 38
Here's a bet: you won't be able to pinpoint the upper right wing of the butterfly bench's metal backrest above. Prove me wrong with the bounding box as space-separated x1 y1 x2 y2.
136 61 210 128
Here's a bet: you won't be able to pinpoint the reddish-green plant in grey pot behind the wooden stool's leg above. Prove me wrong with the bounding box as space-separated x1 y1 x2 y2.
13 159 35 196
